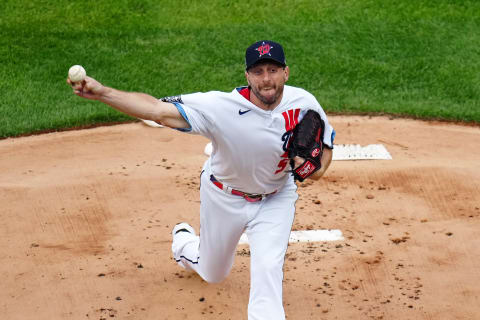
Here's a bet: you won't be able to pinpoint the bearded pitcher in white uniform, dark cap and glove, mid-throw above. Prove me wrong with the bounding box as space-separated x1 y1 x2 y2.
67 40 335 320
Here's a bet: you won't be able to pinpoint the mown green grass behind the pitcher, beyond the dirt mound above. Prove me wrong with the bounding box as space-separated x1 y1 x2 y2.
0 0 480 138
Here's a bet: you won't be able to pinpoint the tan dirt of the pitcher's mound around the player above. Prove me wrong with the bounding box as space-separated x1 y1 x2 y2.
0 116 480 320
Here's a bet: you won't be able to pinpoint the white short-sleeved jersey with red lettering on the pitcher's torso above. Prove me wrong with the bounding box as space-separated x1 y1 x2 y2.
171 86 335 194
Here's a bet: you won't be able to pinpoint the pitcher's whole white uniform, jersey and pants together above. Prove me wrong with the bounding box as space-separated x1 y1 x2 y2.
171 86 335 320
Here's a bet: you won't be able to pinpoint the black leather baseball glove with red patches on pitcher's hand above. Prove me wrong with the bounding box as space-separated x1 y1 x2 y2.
287 110 325 182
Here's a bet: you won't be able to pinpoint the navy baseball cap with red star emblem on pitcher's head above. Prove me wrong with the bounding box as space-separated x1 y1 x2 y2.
245 40 287 70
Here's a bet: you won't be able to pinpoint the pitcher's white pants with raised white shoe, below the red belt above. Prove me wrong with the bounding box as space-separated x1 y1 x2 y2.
172 165 298 320
